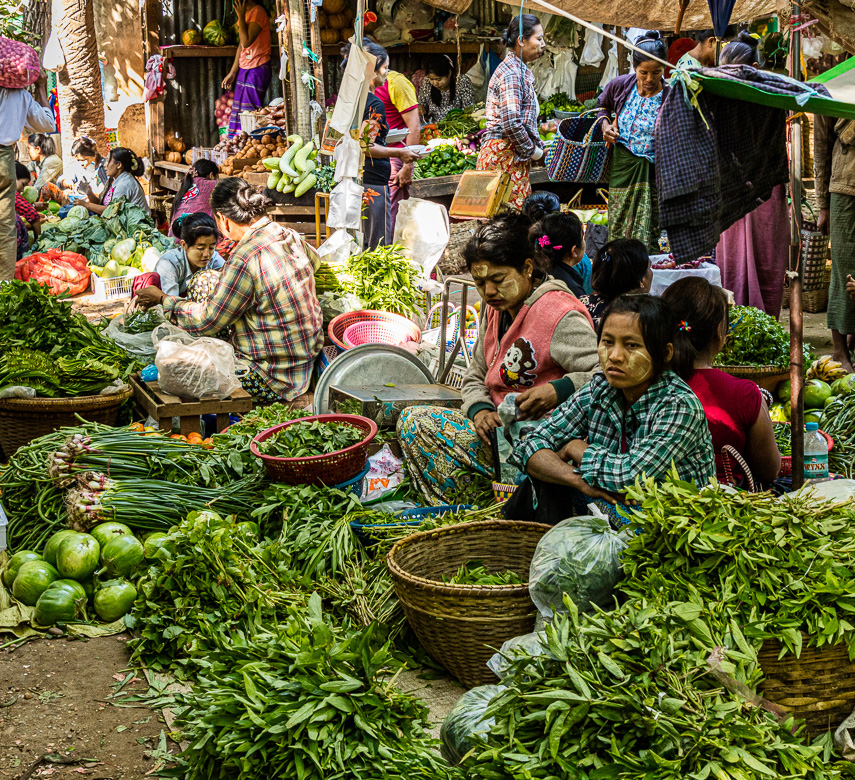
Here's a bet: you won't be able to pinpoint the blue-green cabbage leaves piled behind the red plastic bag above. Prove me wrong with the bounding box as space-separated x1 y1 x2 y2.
38 198 174 270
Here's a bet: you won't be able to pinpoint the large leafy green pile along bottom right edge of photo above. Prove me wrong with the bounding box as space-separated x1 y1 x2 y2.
464 599 851 780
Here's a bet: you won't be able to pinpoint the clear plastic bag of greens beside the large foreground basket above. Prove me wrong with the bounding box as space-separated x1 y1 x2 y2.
528 507 630 617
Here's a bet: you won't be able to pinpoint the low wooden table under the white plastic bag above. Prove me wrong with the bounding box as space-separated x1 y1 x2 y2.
131 375 252 436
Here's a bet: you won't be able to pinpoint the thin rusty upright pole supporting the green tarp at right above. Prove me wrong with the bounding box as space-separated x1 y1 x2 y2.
790 10 805 490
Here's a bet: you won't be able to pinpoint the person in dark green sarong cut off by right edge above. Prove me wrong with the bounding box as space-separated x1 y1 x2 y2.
813 114 855 372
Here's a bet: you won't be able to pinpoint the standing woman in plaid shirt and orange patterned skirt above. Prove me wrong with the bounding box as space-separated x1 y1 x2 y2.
477 14 544 208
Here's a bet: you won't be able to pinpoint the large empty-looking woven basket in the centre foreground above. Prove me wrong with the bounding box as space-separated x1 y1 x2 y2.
387 520 551 687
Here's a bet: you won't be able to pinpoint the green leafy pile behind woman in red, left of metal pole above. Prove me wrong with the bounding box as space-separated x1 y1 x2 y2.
715 306 813 370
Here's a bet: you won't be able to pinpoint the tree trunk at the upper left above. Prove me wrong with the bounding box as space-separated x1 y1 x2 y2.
53 0 109 160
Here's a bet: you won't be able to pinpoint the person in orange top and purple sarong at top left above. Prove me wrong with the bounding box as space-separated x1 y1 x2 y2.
223 0 273 138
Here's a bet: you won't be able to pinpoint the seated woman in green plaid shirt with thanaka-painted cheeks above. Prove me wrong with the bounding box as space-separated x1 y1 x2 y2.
507 295 715 523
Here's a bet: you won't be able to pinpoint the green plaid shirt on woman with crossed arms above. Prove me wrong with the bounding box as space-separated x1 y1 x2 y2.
513 371 715 493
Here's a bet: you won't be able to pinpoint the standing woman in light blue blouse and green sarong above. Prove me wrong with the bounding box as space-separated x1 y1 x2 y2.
597 30 670 252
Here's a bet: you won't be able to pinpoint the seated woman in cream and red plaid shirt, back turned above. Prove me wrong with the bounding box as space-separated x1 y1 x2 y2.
137 178 323 401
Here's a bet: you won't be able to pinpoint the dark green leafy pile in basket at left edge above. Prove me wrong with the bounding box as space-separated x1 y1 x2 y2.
0 281 141 397
